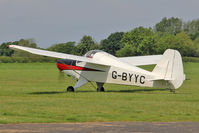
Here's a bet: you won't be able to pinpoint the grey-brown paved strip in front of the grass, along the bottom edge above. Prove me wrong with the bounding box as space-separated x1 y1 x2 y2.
0 122 199 133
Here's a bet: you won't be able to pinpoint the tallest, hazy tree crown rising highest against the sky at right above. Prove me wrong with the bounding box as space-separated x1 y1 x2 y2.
155 17 183 35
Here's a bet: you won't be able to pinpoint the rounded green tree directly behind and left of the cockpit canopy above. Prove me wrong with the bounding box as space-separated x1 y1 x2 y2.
75 36 99 55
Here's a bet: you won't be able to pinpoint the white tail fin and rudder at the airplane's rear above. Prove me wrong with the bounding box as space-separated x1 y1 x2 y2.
153 49 185 89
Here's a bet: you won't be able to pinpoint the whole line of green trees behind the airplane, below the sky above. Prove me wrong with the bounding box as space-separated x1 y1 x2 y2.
0 17 199 59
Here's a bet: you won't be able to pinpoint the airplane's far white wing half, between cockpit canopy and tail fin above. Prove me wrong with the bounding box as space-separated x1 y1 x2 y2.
118 55 162 66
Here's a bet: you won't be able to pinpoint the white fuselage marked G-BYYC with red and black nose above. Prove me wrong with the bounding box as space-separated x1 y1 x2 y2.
57 50 169 88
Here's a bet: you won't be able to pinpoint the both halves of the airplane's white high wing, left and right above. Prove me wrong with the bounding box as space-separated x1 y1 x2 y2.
9 45 162 66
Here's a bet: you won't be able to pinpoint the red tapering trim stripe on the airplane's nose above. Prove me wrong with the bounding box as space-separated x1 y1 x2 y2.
57 63 100 71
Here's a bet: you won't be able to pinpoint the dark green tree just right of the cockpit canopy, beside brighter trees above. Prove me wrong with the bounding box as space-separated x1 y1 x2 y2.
100 32 124 55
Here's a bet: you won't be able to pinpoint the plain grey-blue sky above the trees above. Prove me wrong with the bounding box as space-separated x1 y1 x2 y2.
0 0 199 48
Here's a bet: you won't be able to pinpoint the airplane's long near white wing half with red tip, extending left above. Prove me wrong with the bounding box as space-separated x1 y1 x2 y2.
8 45 111 66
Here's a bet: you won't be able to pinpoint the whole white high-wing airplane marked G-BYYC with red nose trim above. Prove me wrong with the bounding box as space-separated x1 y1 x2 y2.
8 45 185 92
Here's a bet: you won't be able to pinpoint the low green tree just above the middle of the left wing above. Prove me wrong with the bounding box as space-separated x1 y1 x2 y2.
47 42 75 54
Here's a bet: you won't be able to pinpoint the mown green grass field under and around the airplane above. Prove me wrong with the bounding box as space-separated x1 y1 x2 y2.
0 63 199 123
